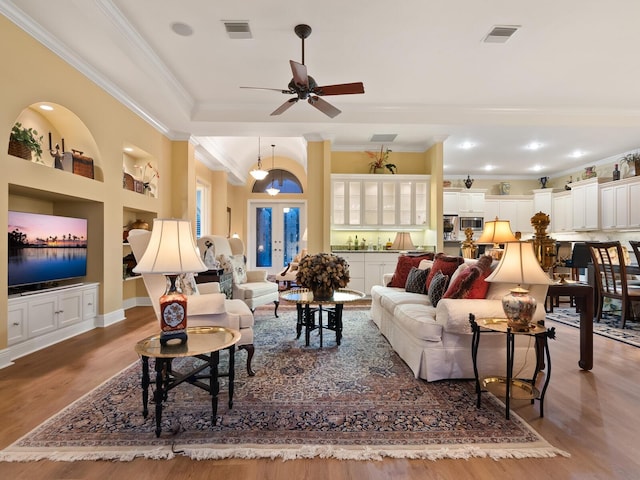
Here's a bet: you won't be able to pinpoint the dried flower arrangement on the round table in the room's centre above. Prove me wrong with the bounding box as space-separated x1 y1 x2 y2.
296 253 349 291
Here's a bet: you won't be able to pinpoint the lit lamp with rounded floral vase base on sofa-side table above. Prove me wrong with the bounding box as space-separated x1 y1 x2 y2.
486 241 551 332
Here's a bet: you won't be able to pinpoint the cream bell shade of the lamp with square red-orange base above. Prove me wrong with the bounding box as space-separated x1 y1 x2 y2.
133 218 207 275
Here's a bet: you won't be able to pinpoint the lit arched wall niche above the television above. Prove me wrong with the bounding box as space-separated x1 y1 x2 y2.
7 102 104 181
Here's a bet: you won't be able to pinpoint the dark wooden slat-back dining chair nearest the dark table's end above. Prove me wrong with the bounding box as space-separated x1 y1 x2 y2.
586 241 640 328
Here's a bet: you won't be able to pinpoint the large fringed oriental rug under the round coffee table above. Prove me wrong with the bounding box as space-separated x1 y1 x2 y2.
0 305 568 461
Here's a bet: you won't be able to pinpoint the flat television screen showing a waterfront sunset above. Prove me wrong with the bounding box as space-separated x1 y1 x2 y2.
8 211 87 287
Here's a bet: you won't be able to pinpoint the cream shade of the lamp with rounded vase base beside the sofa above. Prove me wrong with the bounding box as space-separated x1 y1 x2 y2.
486 241 551 285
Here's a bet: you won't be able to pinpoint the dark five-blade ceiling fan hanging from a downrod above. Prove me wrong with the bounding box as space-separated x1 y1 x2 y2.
240 24 364 118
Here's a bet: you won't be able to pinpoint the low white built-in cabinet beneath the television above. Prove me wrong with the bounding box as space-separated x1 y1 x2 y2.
7 283 98 351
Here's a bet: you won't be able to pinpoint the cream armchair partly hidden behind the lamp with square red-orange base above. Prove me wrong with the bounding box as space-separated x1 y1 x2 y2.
128 229 254 376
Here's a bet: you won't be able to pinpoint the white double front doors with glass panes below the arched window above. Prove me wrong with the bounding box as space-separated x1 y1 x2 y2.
247 201 307 275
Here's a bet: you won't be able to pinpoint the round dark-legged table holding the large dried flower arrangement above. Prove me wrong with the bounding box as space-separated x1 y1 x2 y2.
280 288 365 348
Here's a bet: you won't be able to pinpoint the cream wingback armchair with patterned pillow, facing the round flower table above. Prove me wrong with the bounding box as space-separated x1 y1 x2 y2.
198 235 280 317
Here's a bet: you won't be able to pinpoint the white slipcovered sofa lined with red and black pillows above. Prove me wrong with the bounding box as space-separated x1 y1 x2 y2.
371 259 548 382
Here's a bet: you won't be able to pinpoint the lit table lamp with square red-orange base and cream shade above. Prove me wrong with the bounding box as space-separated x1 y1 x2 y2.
133 219 207 345
